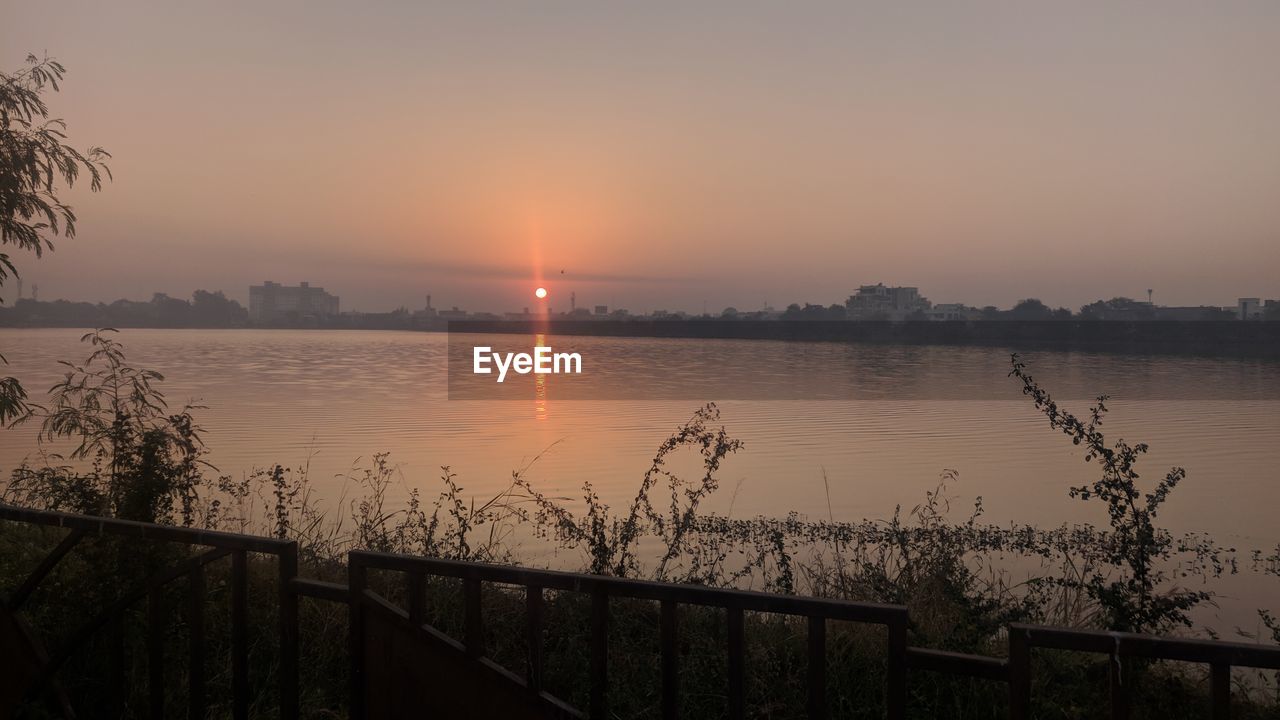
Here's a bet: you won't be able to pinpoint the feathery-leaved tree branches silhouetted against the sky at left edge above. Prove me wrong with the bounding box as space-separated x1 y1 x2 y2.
0 55 111 424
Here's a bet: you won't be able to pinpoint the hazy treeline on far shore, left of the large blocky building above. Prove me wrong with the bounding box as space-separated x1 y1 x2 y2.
0 290 248 328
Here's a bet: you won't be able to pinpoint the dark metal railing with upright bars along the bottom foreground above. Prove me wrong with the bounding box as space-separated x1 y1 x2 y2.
0 505 1280 720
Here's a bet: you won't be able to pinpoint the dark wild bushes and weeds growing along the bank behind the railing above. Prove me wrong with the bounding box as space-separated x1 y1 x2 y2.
0 331 1280 717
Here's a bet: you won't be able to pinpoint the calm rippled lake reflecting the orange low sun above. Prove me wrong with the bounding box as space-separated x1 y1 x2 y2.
0 329 1280 625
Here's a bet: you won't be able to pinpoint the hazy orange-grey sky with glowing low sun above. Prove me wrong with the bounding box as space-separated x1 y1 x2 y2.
0 0 1280 311
